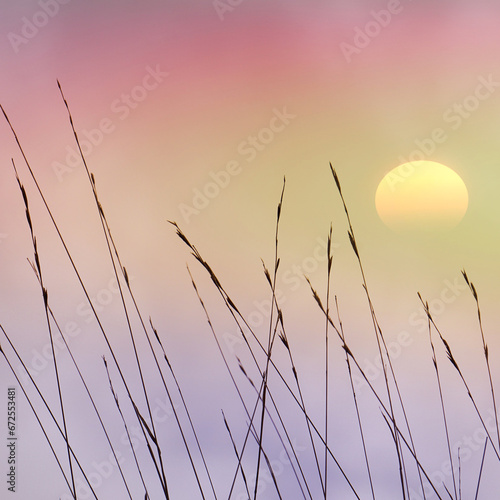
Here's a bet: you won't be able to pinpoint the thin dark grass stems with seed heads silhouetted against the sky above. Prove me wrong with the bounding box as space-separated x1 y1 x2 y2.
0 88 500 500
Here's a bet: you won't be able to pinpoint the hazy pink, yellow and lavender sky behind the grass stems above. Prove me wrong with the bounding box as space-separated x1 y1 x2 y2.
0 0 500 499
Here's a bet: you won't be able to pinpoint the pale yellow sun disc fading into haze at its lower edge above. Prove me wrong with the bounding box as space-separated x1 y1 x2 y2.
375 161 469 232
